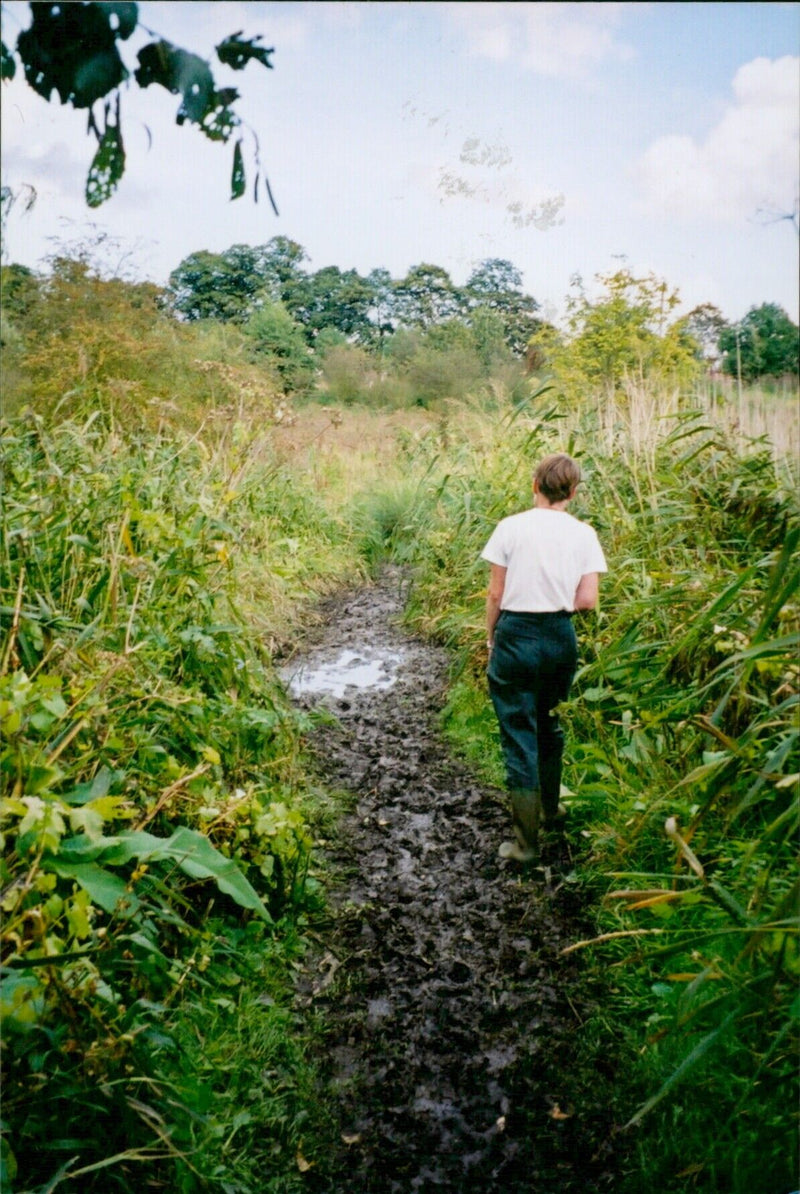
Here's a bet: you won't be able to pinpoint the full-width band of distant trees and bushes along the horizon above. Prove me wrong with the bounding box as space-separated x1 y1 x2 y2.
1 236 799 406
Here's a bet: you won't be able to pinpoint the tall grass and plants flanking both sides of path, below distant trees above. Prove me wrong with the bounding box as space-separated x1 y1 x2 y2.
0 384 800 1194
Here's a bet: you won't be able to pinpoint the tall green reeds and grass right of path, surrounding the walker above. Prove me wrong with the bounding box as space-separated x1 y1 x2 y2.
396 399 800 1194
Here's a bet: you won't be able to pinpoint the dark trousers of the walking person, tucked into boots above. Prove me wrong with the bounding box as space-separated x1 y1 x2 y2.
488 610 578 819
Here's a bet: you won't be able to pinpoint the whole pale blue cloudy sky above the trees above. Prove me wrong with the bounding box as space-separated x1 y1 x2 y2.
2 0 800 320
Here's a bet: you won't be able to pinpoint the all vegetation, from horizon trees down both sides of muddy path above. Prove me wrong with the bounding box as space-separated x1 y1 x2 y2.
0 239 800 1194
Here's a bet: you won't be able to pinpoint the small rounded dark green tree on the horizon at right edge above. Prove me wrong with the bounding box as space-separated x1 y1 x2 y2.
719 302 800 381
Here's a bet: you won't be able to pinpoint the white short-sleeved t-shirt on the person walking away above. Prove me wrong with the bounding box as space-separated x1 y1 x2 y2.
481 506 608 614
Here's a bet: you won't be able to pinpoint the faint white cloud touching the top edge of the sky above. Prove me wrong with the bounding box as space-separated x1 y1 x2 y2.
445 2 634 79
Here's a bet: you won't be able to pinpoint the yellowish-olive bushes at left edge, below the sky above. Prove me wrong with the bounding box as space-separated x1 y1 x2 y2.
0 256 285 429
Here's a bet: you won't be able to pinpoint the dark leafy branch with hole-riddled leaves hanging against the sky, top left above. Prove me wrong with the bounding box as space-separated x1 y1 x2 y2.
0 0 277 207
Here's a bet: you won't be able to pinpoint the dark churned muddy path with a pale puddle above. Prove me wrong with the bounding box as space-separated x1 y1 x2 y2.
289 570 620 1194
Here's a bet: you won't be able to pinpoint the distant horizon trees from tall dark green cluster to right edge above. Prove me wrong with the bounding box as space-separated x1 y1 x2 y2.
168 236 799 381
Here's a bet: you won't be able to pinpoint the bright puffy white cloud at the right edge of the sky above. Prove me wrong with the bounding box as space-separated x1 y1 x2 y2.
635 56 800 222
